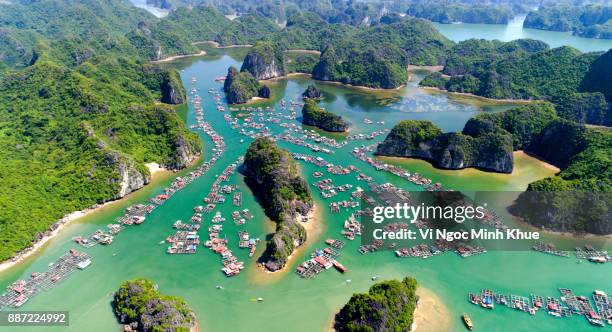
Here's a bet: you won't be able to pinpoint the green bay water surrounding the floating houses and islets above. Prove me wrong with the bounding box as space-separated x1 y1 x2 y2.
0 55 612 331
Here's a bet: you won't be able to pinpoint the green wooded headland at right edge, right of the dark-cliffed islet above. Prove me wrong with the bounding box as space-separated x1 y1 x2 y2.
514 119 612 235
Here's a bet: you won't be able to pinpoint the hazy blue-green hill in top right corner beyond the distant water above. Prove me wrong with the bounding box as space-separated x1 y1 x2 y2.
523 4 612 39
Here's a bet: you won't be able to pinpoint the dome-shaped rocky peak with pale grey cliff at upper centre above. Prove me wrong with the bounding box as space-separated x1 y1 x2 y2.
240 41 285 80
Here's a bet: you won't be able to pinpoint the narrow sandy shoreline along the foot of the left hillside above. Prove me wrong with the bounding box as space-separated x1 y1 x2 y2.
0 163 172 272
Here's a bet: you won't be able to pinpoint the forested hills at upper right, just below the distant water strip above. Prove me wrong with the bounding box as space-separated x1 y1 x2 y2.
419 39 612 125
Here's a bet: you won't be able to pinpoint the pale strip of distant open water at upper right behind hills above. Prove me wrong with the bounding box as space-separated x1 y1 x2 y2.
434 15 612 52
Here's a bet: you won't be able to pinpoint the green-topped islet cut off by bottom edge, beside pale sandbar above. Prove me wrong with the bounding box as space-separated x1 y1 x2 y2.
334 277 418 332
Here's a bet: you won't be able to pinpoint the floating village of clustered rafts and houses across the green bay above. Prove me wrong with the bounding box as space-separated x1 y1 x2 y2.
0 70 612 326
